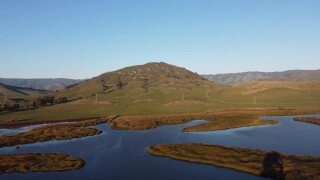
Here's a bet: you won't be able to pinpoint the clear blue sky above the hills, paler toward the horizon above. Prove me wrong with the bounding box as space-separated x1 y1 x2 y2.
0 0 320 78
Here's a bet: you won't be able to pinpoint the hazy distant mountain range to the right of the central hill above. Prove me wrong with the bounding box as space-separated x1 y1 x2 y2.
202 70 320 85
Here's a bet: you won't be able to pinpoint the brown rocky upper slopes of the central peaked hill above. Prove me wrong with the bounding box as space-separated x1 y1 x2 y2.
56 62 224 99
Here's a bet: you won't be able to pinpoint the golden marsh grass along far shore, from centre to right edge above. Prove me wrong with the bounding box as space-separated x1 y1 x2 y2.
109 109 320 132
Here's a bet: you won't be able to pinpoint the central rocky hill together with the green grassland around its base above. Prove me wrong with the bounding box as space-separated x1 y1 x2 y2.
0 62 320 121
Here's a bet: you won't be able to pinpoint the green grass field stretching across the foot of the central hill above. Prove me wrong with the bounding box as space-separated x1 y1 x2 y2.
0 83 320 122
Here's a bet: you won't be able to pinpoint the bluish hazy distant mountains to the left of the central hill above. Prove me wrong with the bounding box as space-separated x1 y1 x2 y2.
0 78 83 91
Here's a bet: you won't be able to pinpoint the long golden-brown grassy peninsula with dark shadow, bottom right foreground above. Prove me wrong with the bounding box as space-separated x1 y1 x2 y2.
147 143 320 179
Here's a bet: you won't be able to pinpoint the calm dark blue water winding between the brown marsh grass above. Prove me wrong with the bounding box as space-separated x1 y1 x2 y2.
0 115 320 180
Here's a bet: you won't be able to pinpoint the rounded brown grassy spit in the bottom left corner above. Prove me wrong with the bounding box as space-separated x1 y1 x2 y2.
0 153 85 174
